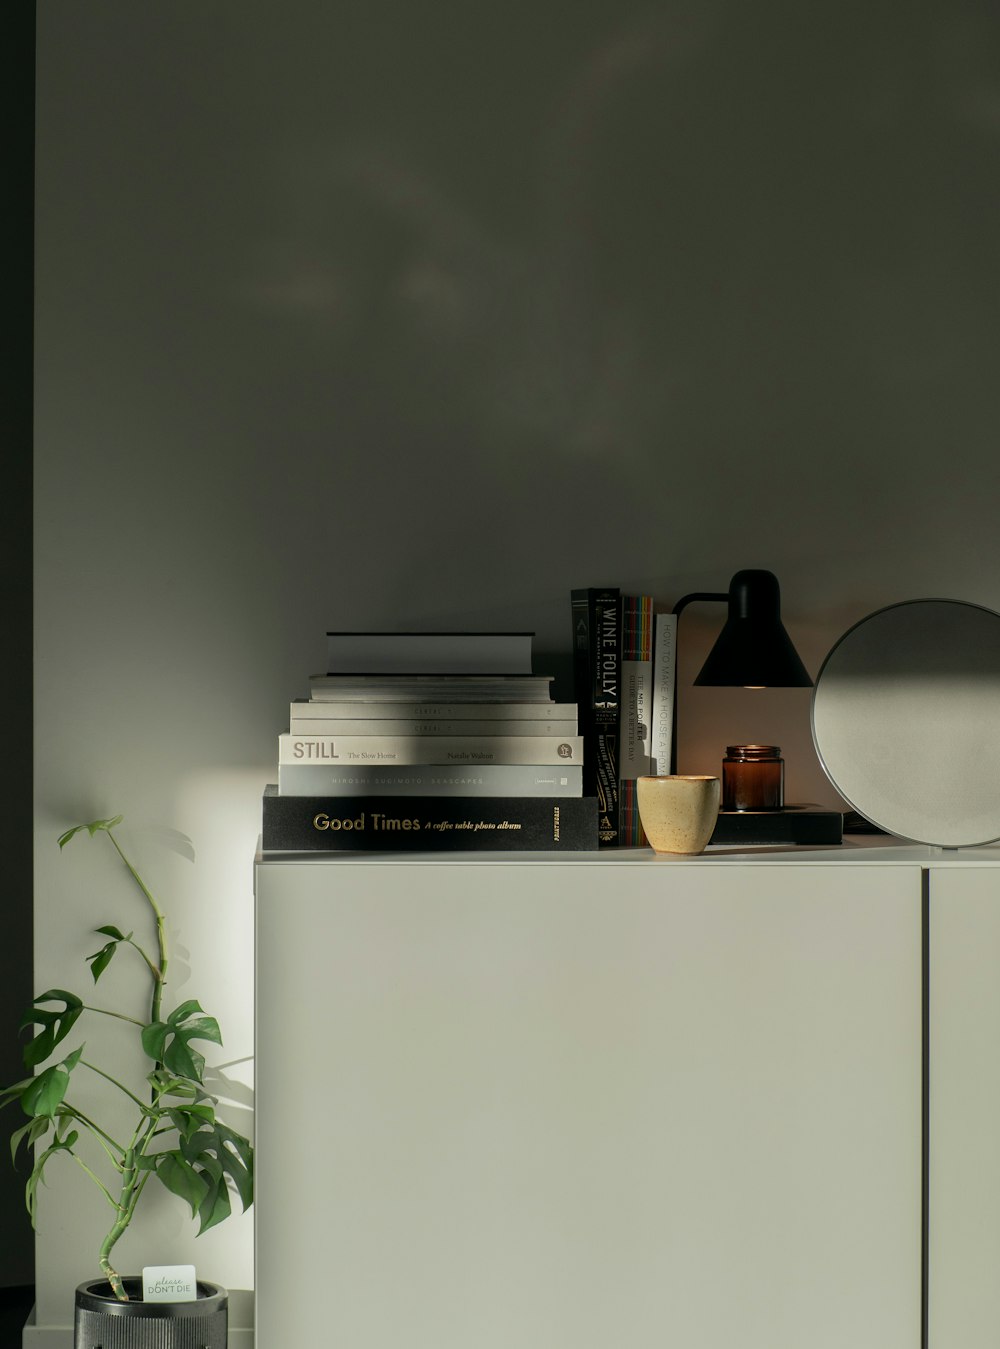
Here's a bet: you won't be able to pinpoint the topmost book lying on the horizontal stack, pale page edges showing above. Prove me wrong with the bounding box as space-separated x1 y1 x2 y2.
327 633 534 675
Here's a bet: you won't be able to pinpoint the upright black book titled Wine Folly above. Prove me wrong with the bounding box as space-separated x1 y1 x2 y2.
571 587 621 847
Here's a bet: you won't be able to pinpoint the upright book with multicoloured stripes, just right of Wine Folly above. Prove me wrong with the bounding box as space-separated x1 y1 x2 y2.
618 595 653 847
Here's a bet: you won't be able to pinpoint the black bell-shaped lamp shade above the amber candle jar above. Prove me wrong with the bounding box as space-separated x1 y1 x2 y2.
695 569 812 688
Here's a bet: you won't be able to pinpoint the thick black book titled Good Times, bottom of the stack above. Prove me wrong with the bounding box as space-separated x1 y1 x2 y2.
260 785 598 853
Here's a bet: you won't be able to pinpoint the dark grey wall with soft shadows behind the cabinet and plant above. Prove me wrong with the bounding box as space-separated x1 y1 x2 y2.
27 0 1000 1323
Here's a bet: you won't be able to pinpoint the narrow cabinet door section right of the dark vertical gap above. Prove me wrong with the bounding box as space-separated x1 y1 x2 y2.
928 865 1000 1349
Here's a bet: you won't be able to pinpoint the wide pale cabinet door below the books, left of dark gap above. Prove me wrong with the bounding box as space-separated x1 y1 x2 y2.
256 858 920 1349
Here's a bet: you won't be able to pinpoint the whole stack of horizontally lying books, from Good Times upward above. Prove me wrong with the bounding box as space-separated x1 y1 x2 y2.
262 633 596 851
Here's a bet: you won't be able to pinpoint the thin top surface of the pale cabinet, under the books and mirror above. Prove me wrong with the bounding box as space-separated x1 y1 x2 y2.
255 835 1000 867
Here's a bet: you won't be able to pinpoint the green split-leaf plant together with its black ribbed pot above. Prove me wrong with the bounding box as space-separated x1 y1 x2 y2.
0 815 254 1349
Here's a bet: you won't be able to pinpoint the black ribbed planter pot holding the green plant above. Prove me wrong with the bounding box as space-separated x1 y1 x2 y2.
73 1278 229 1349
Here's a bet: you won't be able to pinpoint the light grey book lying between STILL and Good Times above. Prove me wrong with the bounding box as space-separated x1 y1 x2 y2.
278 764 583 797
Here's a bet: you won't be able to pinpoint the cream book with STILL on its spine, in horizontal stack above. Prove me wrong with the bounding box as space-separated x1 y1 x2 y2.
278 731 583 768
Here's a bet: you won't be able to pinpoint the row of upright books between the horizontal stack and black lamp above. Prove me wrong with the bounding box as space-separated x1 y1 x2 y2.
571 587 677 847
